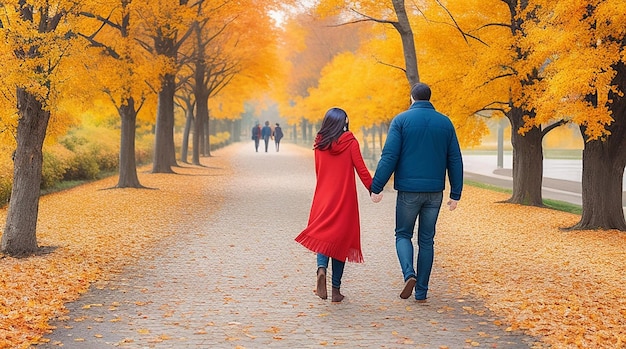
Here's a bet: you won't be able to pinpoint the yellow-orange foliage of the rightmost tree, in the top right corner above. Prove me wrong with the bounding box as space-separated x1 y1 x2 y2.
512 0 626 140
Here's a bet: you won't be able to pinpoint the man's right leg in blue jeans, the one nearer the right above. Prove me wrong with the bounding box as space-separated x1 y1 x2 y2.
415 193 443 300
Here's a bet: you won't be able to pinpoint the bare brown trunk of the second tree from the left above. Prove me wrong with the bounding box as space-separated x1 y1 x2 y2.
117 98 143 188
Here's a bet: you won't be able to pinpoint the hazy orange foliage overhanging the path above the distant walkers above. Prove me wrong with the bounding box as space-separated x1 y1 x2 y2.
204 1 288 119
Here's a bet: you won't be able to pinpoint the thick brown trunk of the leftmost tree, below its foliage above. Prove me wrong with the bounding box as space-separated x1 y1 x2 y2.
1 88 50 257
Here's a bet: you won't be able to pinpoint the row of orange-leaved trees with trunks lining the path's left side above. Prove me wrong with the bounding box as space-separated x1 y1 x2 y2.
0 0 290 256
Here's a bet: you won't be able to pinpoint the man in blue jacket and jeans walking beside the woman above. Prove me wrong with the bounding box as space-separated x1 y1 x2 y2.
371 83 463 302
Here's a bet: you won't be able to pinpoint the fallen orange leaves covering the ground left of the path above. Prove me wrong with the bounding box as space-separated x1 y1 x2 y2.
0 158 229 348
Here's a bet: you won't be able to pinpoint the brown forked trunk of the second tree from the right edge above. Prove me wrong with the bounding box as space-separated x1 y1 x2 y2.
507 107 543 206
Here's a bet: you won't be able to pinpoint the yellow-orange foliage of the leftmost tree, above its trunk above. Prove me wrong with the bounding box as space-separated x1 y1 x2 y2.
0 1 80 142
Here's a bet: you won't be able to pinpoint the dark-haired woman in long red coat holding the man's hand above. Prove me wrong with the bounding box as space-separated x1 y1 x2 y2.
296 108 372 302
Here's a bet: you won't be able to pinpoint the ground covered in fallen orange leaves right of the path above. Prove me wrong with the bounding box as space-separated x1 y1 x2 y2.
436 187 626 348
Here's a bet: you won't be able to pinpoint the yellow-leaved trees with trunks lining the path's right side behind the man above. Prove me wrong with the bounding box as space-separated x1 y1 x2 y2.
318 0 626 230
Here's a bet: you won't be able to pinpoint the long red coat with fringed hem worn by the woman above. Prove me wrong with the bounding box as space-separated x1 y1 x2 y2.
296 131 372 263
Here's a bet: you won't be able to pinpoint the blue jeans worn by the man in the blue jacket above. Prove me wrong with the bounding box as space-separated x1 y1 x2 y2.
396 191 443 299
